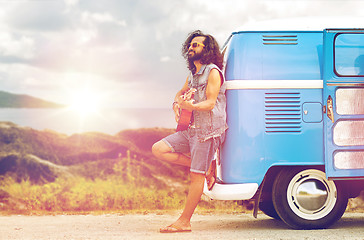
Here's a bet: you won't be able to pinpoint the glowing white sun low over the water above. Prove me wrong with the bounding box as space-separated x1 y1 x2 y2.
70 89 101 115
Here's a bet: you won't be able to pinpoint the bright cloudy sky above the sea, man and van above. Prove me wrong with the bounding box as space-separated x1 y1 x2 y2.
0 0 364 108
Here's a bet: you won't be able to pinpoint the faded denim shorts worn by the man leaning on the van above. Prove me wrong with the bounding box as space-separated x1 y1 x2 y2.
162 129 224 174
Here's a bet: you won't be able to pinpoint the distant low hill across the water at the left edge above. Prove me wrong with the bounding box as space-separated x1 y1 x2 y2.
0 91 64 108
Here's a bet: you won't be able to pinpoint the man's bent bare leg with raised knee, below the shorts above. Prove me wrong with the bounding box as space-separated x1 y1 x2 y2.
152 140 191 167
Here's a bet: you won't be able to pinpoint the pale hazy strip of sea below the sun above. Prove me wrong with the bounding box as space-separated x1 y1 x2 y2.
0 108 176 135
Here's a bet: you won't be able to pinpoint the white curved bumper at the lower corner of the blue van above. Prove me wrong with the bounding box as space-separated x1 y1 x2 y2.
203 180 258 200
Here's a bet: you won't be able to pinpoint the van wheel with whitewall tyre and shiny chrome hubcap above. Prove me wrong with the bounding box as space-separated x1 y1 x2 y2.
272 168 348 229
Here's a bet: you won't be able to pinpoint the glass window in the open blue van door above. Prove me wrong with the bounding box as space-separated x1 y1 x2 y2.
334 33 364 77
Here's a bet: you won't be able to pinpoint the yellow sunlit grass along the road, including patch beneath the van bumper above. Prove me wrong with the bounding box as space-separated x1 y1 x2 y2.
0 154 245 214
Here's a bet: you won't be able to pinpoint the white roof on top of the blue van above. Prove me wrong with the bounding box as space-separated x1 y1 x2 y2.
233 16 364 33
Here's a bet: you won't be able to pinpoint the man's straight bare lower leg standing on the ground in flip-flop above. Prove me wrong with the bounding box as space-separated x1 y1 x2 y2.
160 172 205 232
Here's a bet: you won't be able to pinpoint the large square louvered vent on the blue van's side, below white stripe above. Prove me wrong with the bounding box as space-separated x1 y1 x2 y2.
265 92 302 133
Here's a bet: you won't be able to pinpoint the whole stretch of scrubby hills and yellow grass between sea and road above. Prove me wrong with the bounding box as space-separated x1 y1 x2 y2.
0 122 364 213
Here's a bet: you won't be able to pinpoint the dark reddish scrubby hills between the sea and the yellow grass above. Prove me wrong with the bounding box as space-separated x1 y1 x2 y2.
0 122 182 183
